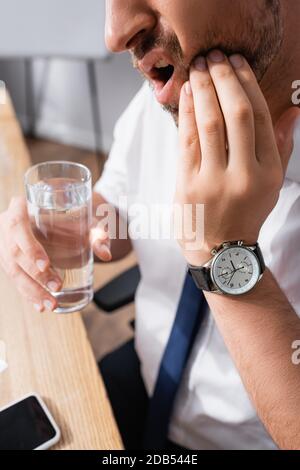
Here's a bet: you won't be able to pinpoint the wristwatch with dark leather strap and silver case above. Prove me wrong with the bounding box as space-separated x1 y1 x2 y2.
188 240 265 295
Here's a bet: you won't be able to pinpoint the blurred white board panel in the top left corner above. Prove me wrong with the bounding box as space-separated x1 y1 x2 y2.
0 0 107 58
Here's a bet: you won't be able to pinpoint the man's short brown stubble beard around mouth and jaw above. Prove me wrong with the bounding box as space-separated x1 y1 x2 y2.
131 0 284 125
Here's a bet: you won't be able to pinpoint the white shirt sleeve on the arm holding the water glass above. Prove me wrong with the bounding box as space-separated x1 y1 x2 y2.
94 86 147 208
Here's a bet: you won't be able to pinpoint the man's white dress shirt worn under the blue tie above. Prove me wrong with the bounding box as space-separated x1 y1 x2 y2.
95 84 300 450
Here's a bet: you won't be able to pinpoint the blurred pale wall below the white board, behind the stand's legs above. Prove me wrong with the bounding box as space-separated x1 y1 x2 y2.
0 54 142 150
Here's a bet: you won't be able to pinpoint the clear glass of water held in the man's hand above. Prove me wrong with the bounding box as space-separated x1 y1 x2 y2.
25 161 93 313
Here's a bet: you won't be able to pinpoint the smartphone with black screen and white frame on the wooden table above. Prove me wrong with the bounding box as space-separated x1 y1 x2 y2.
0 393 60 450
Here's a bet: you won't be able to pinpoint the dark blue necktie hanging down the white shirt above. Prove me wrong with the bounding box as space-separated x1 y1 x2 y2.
144 274 207 450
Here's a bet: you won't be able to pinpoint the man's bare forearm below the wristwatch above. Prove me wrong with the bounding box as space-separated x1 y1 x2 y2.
206 270 300 449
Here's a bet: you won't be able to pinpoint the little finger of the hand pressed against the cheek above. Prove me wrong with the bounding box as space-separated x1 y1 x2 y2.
178 82 201 176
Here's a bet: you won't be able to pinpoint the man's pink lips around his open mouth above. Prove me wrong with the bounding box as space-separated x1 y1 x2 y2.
138 49 176 105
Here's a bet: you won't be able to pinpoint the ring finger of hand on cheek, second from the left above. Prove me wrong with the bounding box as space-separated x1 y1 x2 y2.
190 57 227 167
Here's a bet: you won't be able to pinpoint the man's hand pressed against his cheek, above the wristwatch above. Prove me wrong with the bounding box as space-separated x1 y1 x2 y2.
175 51 299 265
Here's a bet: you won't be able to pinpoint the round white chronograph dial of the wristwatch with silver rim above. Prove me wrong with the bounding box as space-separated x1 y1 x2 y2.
211 246 261 295
